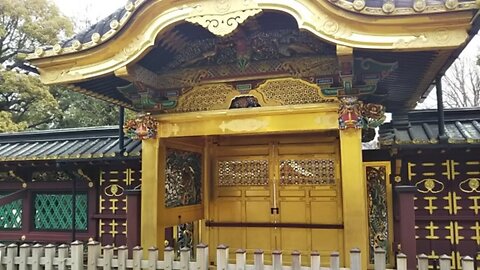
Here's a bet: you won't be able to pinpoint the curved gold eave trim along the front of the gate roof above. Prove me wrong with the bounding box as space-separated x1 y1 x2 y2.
28 0 473 84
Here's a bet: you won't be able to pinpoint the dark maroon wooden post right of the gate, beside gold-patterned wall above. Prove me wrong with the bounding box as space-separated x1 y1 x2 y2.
395 186 417 270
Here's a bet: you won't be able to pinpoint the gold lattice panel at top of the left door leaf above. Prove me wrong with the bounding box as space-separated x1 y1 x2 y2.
217 160 269 186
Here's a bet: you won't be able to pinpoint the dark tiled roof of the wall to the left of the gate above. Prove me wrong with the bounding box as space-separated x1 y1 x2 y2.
0 126 142 162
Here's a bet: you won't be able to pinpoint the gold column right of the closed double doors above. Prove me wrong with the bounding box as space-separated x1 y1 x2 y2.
340 128 368 269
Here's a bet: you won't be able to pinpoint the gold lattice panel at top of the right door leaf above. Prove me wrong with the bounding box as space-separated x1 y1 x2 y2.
280 159 335 185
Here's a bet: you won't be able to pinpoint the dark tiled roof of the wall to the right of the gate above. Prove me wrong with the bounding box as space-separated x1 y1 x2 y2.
379 108 480 148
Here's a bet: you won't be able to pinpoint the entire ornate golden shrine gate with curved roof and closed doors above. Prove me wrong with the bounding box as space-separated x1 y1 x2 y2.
15 0 480 269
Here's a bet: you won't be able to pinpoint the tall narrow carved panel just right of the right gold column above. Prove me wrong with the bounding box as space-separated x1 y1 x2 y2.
366 166 390 263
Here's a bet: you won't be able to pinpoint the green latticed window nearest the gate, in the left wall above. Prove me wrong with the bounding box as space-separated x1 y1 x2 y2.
34 193 88 230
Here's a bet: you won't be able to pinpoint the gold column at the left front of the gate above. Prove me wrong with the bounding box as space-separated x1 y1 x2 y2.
140 138 165 254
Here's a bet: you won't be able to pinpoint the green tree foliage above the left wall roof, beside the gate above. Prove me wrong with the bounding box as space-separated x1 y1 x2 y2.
0 0 124 132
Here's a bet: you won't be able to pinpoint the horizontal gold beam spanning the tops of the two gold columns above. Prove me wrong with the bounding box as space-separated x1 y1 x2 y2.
156 102 338 138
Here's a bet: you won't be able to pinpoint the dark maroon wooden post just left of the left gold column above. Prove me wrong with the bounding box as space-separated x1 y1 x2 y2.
125 189 141 250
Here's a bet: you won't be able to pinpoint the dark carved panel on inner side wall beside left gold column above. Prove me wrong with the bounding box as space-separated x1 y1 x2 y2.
165 149 202 208
